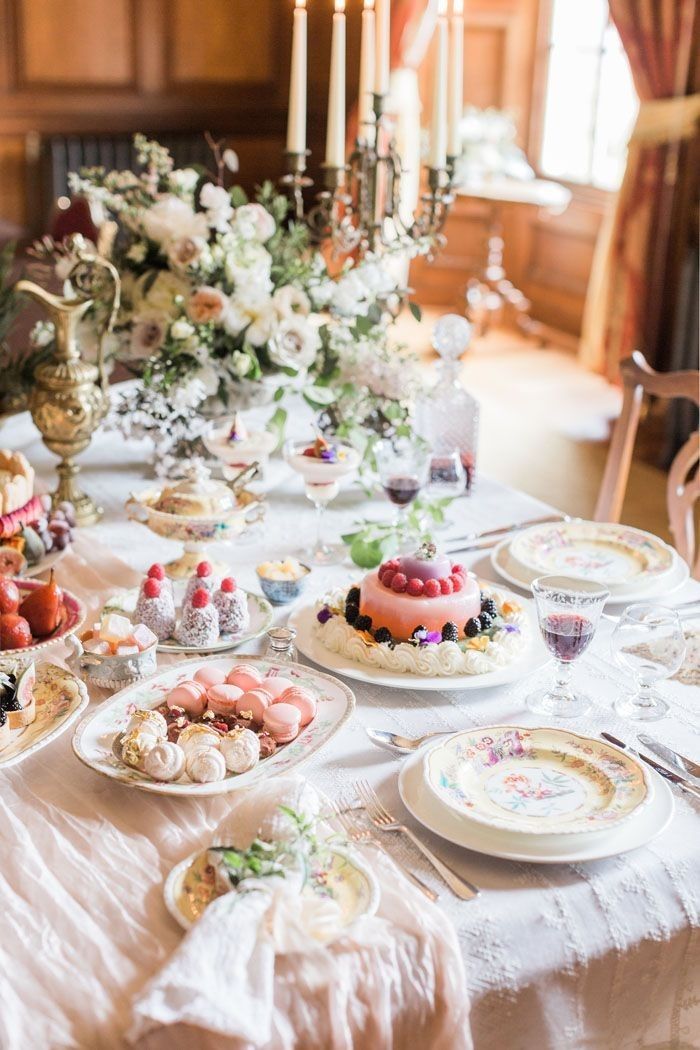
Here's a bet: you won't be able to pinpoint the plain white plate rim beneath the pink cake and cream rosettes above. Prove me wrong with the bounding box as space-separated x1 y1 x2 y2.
290 595 551 691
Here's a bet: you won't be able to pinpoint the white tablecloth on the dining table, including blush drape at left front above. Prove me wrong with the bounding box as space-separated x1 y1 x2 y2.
0 407 700 1050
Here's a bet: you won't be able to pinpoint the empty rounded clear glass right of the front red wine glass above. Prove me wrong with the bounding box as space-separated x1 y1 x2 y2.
610 602 685 721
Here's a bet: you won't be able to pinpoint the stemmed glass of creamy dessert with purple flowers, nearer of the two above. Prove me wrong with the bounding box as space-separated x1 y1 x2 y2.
283 437 360 565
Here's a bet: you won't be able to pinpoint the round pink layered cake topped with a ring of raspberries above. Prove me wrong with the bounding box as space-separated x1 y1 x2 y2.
359 544 481 642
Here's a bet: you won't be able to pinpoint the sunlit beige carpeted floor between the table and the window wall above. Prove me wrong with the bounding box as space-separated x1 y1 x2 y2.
399 309 670 539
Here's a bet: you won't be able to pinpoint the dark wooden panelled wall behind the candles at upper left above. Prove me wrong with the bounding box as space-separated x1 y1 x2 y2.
0 0 359 235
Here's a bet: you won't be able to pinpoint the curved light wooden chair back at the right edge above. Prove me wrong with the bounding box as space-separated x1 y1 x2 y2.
594 351 700 579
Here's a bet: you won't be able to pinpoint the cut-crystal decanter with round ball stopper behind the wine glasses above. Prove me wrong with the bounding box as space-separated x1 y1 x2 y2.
416 314 480 492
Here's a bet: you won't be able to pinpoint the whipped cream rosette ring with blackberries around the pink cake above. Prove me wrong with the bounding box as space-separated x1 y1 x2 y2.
314 584 530 677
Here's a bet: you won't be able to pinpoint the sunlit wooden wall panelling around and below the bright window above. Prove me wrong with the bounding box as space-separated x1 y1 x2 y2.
411 0 607 337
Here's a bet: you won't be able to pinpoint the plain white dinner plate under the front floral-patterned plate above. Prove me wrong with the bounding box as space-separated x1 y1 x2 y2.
399 749 674 864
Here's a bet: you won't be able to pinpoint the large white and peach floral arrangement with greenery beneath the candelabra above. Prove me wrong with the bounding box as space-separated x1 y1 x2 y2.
30 135 429 466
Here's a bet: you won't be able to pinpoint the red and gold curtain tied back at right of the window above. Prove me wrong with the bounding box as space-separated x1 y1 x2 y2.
582 0 700 378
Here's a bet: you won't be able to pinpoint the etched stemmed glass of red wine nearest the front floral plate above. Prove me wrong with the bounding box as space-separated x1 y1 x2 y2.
527 576 610 718
